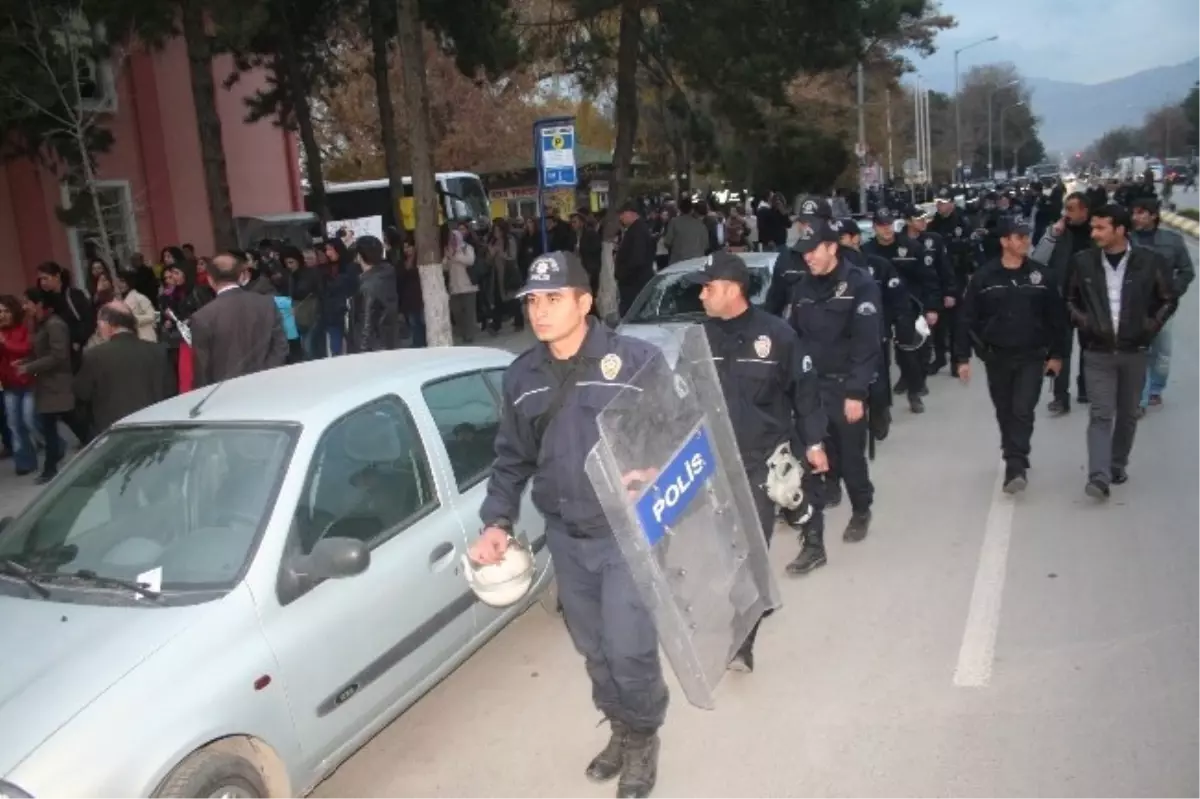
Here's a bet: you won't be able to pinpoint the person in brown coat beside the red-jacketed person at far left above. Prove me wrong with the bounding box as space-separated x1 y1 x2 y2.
17 288 74 486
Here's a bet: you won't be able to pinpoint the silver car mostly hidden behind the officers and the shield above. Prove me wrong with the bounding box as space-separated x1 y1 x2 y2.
617 252 776 364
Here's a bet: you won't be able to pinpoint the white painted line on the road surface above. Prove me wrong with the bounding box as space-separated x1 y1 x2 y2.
954 464 1014 687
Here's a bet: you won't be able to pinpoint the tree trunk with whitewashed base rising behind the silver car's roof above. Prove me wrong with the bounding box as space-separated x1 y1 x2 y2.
396 0 454 347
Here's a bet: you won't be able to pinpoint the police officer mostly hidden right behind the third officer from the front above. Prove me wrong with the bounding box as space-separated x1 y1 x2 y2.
840 220 902 453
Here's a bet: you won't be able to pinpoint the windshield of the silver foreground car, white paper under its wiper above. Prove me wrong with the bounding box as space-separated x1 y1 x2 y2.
0 425 295 593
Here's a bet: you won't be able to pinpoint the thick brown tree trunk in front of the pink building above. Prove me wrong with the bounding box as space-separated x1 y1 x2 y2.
180 0 238 250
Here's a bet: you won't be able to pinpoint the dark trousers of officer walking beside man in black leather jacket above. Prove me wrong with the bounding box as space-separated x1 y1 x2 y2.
984 350 1046 469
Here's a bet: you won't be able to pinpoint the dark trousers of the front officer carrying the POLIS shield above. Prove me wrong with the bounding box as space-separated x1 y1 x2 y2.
546 518 670 733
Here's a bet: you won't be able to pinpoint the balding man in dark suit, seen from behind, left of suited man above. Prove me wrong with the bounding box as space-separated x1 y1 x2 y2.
74 301 174 435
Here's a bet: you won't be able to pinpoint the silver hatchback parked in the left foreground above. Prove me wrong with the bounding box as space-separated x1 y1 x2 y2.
0 348 552 799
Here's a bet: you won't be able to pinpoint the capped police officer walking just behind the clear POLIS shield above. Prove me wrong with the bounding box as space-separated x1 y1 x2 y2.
686 251 829 672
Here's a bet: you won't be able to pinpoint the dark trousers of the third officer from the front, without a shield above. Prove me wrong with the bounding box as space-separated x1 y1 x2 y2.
804 374 873 511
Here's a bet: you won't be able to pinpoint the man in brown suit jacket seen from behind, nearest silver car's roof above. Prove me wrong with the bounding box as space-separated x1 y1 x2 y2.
190 252 288 389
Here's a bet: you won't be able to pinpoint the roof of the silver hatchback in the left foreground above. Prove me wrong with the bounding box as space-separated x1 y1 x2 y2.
119 347 515 426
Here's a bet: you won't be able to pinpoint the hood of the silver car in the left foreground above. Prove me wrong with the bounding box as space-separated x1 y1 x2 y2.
0 596 214 776
